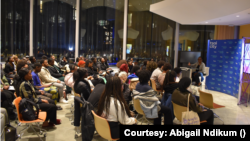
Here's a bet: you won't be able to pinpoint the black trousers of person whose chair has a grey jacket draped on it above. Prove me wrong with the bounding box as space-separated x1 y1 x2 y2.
154 105 173 125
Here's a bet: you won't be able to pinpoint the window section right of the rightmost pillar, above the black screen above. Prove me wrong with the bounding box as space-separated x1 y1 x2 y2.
179 25 215 66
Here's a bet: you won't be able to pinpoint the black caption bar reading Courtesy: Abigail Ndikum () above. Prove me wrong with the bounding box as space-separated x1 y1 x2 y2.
120 125 250 141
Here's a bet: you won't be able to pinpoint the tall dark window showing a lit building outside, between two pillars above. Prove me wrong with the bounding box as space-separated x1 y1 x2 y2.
79 0 124 63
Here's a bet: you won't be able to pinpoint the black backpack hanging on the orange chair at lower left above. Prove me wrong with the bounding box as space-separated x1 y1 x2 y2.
19 98 39 121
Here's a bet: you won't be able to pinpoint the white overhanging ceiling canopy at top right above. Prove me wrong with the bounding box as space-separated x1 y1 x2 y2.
150 0 250 26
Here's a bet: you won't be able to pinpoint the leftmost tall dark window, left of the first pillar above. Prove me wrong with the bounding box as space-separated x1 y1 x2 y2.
0 0 30 61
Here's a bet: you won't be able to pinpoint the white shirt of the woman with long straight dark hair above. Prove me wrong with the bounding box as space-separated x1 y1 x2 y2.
102 97 136 125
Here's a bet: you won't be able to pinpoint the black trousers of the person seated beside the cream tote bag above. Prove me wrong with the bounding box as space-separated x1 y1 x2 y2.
198 109 214 125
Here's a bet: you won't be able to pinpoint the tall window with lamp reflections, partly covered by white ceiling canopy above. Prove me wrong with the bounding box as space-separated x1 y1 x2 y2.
127 0 175 64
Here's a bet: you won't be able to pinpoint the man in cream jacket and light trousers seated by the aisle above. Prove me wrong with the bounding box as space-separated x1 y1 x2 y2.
38 59 68 103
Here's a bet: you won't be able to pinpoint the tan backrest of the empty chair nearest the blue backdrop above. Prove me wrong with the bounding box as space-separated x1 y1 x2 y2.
199 89 214 108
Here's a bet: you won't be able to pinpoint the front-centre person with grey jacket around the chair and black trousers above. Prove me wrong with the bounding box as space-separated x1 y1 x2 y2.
132 70 173 125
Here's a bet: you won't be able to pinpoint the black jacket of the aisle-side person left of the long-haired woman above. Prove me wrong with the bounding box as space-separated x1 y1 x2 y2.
74 79 91 100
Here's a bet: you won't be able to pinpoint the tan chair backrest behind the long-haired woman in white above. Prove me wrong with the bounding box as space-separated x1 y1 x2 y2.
92 110 119 140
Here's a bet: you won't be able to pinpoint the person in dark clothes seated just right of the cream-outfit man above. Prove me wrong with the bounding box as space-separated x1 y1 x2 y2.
46 58 65 81
